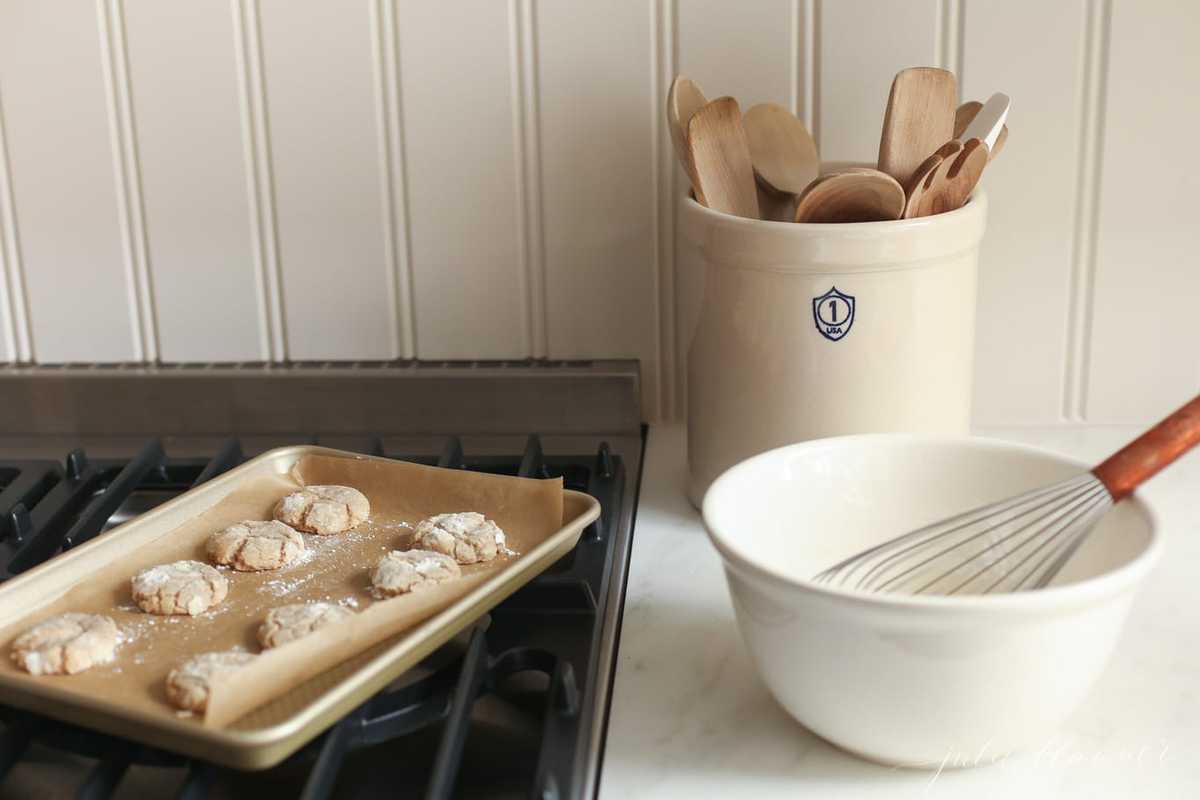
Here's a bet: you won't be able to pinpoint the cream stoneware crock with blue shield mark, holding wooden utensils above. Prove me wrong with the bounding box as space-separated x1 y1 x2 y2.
680 185 988 506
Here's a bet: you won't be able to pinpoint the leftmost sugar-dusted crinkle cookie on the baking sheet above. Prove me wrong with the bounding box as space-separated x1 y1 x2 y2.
12 612 119 675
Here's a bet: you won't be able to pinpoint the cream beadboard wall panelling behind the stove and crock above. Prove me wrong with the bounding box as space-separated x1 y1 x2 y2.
0 0 1200 426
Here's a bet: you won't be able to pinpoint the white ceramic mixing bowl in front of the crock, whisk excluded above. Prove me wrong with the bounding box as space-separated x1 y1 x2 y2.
703 434 1158 768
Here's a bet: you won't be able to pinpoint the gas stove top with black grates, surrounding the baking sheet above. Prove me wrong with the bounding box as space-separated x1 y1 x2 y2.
0 367 643 799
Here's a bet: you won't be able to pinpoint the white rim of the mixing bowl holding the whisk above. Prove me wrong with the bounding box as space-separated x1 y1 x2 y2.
701 433 1162 612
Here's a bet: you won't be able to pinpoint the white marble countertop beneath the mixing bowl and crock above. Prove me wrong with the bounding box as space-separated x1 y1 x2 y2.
600 426 1200 800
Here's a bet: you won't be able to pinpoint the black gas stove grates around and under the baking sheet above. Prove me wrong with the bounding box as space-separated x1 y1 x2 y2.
0 435 631 799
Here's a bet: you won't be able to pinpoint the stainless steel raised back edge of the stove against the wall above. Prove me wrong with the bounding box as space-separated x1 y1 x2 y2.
0 360 642 435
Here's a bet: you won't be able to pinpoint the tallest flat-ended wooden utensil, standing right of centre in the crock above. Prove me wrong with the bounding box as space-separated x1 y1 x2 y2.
878 67 958 184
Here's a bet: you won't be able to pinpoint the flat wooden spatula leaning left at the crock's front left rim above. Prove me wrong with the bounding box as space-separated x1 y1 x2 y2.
688 97 760 219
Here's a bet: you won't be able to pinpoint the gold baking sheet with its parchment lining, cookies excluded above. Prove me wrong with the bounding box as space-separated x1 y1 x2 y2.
0 446 599 769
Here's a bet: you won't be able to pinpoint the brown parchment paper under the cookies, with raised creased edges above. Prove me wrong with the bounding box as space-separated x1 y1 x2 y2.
0 455 563 726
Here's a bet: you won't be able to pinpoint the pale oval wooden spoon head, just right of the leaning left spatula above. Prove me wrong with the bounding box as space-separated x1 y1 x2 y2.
742 103 821 194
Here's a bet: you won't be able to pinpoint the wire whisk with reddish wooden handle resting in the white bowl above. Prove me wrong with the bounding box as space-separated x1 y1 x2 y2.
814 397 1200 595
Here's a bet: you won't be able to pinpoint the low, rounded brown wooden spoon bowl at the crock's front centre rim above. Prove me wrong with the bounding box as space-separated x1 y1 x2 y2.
796 167 905 222
